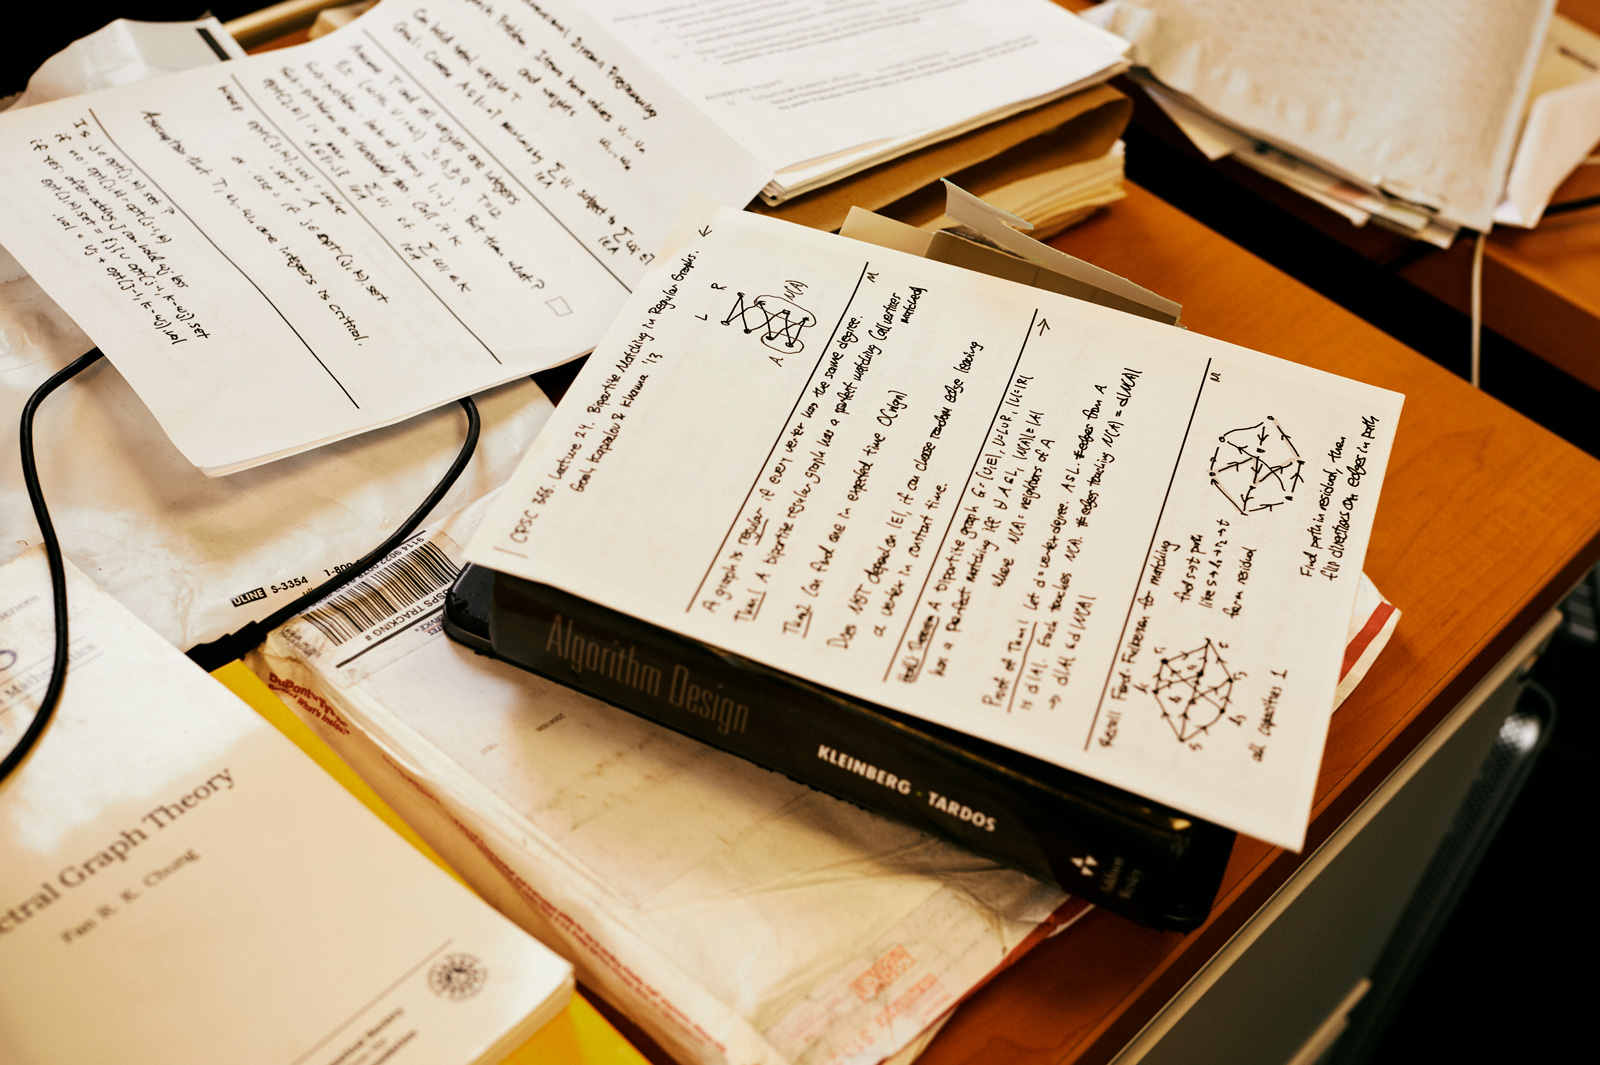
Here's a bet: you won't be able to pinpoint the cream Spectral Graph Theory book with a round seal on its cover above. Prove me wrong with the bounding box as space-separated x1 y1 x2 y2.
0 550 571 1065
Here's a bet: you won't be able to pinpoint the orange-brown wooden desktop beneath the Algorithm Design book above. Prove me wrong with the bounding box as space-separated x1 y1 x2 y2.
922 185 1600 1065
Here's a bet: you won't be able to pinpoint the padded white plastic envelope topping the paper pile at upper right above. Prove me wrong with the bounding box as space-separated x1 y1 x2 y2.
1109 0 1555 230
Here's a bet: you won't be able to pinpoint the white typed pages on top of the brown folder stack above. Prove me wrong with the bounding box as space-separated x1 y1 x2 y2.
594 0 1128 198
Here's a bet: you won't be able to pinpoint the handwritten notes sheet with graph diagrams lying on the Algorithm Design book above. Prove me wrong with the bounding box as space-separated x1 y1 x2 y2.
467 205 1402 848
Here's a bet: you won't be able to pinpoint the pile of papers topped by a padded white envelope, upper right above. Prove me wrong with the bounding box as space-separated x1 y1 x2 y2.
1094 0 1600 238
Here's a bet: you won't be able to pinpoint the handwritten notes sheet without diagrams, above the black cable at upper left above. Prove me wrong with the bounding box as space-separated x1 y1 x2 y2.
0 0 766 473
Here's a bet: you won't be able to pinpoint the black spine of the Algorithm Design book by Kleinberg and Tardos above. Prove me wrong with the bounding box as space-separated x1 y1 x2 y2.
446 568 1234 929
